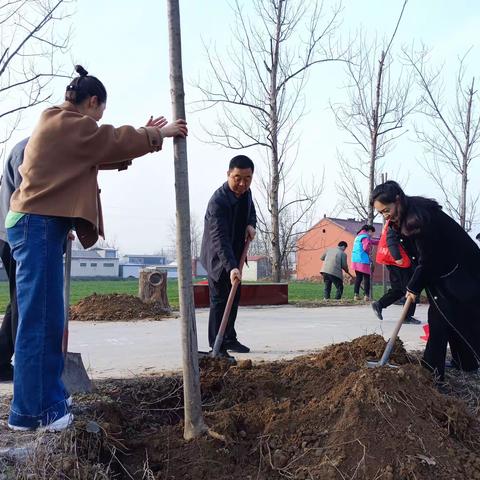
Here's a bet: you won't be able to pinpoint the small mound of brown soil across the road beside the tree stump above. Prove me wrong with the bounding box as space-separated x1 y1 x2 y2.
70 293 170 322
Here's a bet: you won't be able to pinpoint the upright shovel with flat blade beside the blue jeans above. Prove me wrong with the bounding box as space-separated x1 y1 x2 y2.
62 238 93 393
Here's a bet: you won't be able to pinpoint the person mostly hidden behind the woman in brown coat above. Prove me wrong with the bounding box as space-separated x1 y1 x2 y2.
0 138 28 381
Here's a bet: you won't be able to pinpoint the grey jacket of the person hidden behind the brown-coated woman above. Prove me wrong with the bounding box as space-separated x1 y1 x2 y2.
0 138 28 242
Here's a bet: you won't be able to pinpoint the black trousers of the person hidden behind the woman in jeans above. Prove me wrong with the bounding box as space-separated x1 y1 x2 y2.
0 240 18 368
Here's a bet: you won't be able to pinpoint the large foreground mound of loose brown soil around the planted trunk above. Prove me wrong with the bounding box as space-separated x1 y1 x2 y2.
3 335 480 480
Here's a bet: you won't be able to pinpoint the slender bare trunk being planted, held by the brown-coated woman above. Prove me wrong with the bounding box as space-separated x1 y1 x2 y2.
168 0 207 440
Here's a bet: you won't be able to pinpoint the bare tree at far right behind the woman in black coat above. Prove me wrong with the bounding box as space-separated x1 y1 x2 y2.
405 48 480 232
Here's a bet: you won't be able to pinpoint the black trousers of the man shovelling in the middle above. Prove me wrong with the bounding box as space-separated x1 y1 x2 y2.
208 270 242 348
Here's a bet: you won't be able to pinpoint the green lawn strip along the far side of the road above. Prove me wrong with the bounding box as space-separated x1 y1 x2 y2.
0 280 382 313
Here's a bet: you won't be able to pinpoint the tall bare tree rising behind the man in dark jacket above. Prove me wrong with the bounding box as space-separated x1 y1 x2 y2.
197 0 343 281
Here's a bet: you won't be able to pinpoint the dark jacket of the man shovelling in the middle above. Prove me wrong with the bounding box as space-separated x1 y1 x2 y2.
200 182 257 281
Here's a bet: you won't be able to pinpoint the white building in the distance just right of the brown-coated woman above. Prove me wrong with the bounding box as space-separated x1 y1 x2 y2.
71 248 119 278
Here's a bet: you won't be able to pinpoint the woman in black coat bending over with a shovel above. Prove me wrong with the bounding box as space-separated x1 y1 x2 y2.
370 181 480 380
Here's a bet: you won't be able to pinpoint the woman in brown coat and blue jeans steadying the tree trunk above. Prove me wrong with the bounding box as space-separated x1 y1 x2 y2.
5 66 187 430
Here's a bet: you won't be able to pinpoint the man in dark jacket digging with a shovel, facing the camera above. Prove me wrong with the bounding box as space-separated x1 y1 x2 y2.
200 155 257 357
